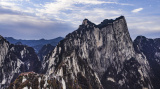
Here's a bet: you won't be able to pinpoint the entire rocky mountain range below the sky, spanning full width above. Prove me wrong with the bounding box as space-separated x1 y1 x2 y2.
0 16 160 89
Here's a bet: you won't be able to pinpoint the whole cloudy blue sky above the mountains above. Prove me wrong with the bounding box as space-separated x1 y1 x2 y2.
0 0 160 40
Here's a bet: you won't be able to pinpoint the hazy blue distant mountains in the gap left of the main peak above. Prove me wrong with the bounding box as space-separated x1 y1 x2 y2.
5 37 63 53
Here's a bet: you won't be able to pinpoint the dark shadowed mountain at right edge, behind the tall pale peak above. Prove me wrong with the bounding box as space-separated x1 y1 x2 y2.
134 36 160 89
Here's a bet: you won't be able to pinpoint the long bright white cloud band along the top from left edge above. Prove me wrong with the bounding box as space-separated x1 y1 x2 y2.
0 0 131 21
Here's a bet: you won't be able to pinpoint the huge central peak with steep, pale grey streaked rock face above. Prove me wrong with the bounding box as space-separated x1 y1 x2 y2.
43 16 152 89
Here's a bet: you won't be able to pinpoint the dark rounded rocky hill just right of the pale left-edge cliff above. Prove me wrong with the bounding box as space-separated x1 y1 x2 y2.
10 45 41 73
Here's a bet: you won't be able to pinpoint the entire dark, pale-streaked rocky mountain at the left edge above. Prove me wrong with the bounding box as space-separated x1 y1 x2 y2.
0 36 41 89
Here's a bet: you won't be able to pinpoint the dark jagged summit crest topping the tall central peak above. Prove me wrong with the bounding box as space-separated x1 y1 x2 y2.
65 16 129 39
